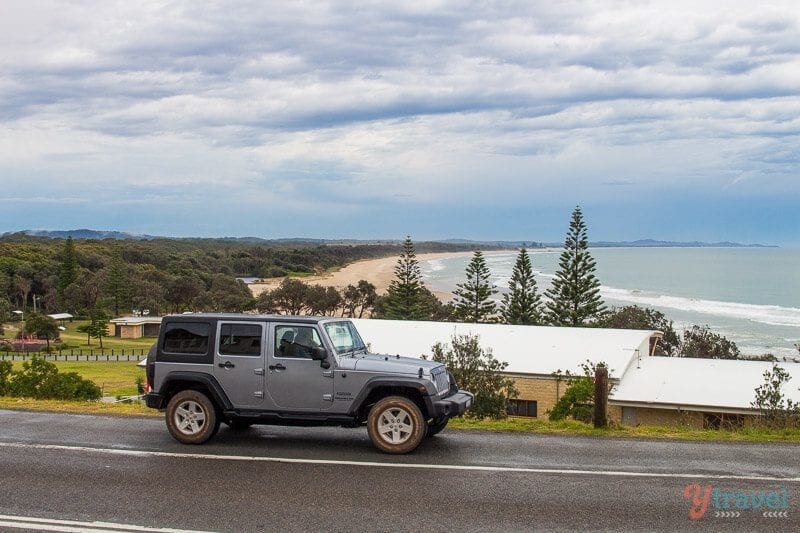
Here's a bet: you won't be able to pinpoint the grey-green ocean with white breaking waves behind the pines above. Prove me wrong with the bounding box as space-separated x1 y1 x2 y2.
420 248 800 357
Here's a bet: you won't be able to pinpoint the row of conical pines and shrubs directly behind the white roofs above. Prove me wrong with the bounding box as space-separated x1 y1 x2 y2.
374 207 764 360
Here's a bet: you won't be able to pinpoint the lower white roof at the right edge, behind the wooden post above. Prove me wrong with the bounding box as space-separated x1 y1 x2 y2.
609 357 800 414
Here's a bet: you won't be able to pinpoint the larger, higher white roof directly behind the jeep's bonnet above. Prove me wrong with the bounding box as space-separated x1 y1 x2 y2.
353 319 661 378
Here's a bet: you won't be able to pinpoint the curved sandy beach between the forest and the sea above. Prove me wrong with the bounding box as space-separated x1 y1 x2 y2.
250 250 508 301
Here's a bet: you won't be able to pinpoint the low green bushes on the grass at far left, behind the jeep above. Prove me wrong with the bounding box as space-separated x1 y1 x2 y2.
6 358 102 400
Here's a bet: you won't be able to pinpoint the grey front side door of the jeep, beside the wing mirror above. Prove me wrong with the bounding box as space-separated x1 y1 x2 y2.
267 323 333 411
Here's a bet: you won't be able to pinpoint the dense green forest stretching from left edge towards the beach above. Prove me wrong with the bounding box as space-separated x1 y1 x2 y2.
0 234 488 323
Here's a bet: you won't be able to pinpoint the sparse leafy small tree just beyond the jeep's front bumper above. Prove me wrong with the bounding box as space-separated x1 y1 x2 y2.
433 335 518 418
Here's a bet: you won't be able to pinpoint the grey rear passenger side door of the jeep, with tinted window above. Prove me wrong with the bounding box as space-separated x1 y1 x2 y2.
214 320 267 409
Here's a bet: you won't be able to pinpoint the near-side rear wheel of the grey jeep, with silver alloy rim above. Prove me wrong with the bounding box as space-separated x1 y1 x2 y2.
166 390 220 444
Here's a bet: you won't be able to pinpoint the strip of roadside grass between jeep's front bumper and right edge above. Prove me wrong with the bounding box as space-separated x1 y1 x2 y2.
448 418 800 443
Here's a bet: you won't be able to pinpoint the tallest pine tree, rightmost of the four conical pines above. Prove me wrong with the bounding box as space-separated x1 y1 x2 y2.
546 206 605 326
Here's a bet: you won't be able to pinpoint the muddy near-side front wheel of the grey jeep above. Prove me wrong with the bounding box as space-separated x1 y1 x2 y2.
367 396 427 453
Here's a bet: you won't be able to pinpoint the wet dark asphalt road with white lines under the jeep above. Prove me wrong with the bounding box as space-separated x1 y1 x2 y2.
0 411 800 531
